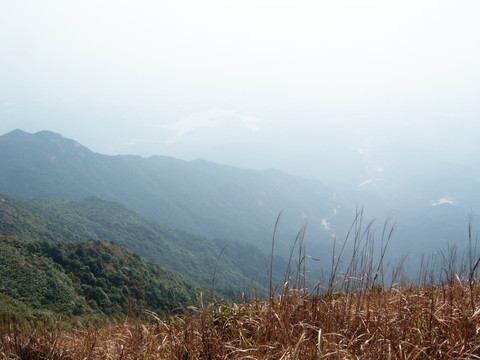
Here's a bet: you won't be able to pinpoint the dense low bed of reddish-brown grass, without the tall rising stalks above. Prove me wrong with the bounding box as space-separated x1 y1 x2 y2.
0 281 480 359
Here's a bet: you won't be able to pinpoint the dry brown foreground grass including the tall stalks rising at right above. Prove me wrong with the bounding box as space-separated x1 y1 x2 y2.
0 212 480 360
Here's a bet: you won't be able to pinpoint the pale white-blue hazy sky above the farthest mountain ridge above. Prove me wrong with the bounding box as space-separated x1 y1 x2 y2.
0 0 480 183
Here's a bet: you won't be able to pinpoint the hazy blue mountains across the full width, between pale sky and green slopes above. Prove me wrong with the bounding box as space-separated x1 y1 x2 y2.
0 130 480 276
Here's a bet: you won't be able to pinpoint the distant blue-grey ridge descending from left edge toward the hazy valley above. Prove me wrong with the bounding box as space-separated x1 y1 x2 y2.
0 130 344 256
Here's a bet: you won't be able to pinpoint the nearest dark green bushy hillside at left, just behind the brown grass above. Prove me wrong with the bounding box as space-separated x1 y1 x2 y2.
0 235 198 321
